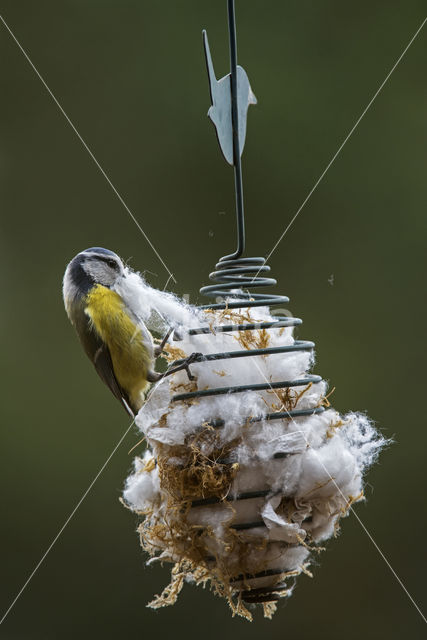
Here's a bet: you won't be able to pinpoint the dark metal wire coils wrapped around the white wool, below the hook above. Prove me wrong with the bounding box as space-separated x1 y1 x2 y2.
172 252 325 603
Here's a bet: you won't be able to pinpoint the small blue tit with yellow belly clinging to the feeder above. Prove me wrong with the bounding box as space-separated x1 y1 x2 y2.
63 247 200 418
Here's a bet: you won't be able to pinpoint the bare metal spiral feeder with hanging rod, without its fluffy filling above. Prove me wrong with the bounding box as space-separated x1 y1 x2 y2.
166 0 325 603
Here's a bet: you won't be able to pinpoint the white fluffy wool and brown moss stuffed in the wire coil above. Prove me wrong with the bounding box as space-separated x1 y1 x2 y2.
120 272 384 620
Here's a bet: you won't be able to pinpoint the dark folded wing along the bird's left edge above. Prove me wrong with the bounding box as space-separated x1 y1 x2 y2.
71 304 135 418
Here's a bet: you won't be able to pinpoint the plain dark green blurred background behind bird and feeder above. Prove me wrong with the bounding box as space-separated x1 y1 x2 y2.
0 0 427 640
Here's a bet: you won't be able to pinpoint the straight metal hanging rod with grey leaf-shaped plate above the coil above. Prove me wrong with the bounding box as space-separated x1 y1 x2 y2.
203 0 257 262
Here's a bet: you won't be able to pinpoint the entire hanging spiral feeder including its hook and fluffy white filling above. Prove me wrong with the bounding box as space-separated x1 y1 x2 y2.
123 0 386 620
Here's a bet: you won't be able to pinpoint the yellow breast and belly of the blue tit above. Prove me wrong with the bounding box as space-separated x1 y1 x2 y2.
85 284 152 409
